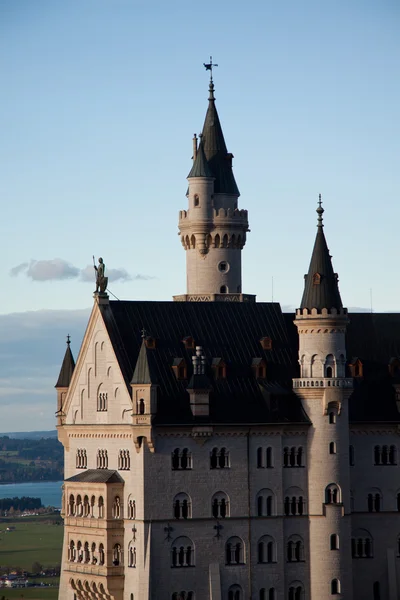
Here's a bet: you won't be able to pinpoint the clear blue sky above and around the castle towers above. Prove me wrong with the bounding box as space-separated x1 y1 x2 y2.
0 0 400 429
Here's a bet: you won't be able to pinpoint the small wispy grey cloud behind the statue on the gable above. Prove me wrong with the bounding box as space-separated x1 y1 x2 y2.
10 258 154 283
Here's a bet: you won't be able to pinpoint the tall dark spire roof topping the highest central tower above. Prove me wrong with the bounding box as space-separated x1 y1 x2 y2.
201 83 240 196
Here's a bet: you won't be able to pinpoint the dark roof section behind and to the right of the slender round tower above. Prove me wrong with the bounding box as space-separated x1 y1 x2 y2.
284 313 400 423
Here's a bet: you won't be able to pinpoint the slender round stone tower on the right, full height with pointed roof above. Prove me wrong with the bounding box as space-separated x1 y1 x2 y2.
293 196 353 600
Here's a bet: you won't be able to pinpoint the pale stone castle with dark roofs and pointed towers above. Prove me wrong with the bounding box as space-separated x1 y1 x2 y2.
56 78 400 600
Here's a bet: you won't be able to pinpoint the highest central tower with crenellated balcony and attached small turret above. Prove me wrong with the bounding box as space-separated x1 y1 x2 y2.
175 77 251 301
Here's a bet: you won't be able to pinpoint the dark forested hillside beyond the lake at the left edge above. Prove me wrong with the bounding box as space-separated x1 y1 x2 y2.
0 436 64 483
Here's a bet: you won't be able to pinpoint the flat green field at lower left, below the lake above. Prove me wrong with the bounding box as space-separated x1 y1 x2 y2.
0 516 63 572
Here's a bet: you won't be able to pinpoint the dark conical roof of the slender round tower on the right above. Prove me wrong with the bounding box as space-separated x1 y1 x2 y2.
300 195 343 311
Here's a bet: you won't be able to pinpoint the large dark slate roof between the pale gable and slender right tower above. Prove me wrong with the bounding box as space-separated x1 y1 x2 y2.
100 301 309 425
